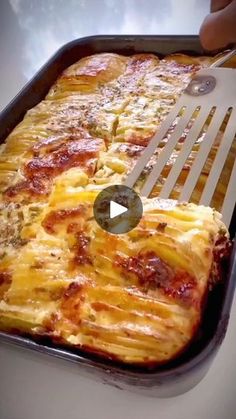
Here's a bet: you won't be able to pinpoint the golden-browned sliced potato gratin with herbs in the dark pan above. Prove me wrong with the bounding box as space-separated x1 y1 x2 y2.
0 53 233 365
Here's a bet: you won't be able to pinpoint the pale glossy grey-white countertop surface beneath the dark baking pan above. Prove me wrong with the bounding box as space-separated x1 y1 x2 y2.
0 0 236 419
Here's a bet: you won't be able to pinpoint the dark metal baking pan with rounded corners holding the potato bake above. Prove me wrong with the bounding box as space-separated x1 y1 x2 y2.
0 36 235 396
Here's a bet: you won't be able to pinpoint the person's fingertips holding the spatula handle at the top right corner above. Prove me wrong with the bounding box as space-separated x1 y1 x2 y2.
199 0 236 50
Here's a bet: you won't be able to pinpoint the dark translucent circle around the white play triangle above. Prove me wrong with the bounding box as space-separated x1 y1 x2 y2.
93 185 143 234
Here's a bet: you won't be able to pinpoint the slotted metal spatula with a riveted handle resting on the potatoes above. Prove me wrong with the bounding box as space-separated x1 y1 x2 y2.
125 49 236 226
